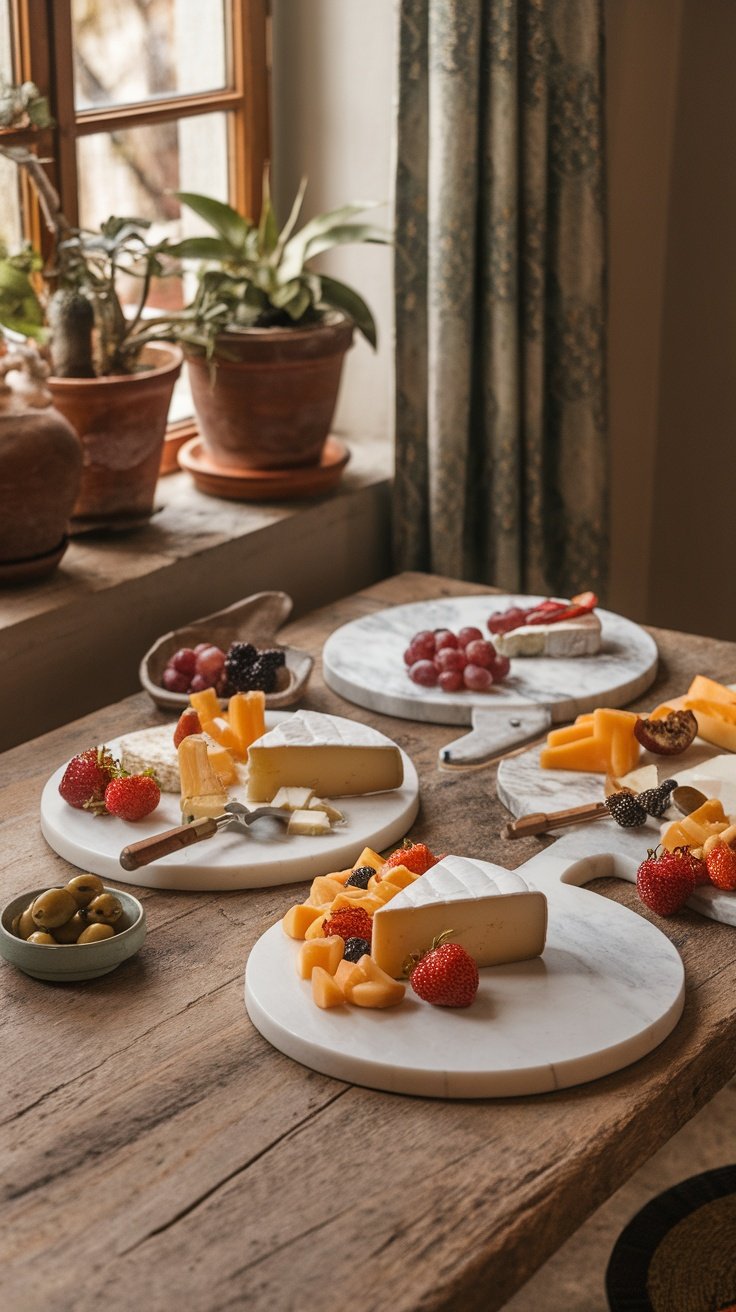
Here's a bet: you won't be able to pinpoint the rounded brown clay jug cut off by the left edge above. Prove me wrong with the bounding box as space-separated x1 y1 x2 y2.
0 346 81 583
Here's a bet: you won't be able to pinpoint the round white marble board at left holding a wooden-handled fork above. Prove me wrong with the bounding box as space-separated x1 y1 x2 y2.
41 711 419 891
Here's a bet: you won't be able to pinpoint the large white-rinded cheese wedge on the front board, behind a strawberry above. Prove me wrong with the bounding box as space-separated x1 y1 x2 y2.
371 857 547 979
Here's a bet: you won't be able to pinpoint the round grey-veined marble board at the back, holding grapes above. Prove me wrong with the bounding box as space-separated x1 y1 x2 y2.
323 594 657 724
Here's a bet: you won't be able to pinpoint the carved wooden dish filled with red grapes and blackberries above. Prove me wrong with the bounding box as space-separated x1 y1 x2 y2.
139 592 314 711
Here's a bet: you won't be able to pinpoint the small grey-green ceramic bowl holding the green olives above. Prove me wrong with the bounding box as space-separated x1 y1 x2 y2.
0 884 146 984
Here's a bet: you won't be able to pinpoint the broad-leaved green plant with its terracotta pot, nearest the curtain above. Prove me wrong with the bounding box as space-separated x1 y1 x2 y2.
168 174 387 470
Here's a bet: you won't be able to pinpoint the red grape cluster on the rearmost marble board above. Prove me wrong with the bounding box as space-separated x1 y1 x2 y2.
404 627 510 693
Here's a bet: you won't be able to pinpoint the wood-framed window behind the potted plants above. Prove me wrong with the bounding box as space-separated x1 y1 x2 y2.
0 0 268 425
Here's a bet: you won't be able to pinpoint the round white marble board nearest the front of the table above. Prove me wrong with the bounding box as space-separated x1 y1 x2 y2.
245 845 685 1098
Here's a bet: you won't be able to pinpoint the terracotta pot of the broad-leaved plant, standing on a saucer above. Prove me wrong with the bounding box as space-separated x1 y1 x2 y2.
186 315 353 470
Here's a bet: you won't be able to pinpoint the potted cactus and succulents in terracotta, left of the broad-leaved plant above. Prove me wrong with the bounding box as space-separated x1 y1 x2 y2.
0 83 182 526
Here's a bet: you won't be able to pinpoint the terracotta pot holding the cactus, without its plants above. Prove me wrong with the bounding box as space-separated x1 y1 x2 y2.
49 342 182 527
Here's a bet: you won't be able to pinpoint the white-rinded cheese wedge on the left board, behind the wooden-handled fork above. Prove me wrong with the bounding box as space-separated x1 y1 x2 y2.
242 711 404 802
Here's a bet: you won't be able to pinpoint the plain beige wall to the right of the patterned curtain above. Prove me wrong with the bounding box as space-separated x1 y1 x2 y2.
606 0 736 635
